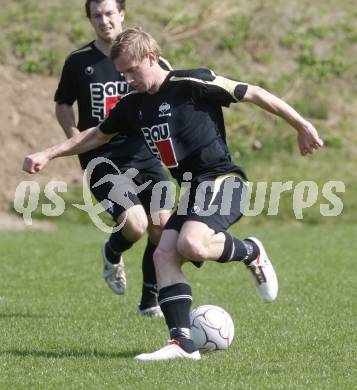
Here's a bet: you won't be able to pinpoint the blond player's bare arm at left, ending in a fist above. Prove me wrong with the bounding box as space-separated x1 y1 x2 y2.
22 127 114 173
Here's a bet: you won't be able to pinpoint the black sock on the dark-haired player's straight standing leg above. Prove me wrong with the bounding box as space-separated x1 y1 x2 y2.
139 239 157 310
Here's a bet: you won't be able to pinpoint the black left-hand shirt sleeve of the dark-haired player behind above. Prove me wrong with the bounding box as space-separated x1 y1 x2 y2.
54 58 78 106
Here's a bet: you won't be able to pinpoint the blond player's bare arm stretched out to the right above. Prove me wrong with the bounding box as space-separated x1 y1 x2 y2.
242 85 323 156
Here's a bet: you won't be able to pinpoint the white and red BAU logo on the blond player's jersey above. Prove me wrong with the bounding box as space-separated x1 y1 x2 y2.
141 123 178 168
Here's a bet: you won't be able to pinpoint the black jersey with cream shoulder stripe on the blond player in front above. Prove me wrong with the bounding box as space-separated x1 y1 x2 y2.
100 69 247 182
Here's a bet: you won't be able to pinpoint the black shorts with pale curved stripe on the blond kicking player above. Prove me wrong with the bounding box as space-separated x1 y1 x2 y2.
165 173 248 232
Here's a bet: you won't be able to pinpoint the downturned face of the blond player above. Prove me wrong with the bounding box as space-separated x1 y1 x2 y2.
113 53 152 92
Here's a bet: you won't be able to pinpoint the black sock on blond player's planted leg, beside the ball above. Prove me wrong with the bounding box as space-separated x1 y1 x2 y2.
159 283 196 353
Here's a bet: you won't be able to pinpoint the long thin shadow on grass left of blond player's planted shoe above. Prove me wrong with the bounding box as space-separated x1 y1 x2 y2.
0 349 142 359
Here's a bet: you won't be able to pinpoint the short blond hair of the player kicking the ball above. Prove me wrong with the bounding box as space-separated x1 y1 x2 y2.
110 27 161 61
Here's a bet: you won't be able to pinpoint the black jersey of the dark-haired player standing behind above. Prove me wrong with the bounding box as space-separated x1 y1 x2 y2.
54 41 171 169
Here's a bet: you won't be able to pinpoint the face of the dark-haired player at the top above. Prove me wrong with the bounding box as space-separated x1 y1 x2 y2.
90 0 124 42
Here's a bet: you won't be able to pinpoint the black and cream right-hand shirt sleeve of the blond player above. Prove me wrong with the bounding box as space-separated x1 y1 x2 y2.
185 69 248 107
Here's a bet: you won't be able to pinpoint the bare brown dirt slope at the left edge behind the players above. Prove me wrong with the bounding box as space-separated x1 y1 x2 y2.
0 65 82 228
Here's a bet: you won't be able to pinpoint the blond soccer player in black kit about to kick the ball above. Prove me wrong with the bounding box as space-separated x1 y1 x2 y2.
23 28 322 361
